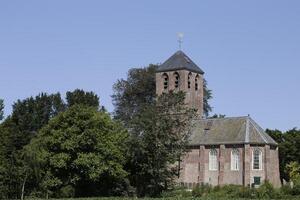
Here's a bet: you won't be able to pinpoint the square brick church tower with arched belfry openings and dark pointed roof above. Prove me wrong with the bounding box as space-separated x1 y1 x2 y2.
156 50 204 117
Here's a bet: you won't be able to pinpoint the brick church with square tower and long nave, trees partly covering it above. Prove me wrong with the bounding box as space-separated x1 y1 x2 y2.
156 51 281 188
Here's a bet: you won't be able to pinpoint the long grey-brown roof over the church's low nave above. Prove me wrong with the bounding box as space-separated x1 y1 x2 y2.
190 116 277 146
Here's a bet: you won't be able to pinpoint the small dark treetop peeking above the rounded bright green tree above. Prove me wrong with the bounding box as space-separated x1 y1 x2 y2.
66 89 99 108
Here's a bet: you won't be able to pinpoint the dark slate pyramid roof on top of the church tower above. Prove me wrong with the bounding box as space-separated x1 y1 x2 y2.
157 51 204 74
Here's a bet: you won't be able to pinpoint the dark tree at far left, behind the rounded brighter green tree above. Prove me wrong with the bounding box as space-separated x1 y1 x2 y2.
1 93 65 198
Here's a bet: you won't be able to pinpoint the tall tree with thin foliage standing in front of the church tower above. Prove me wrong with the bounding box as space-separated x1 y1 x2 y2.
128 92 195 196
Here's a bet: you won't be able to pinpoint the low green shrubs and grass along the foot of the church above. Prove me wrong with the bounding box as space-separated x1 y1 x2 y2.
22 182 300 200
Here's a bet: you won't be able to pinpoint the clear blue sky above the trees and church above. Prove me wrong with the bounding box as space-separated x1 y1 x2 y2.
0 0 300 131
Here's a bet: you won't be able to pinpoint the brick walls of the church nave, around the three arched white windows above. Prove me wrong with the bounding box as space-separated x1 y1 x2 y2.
178 144 281 187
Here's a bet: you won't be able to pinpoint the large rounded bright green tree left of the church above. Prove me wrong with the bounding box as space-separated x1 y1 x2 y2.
29 105 127 197
